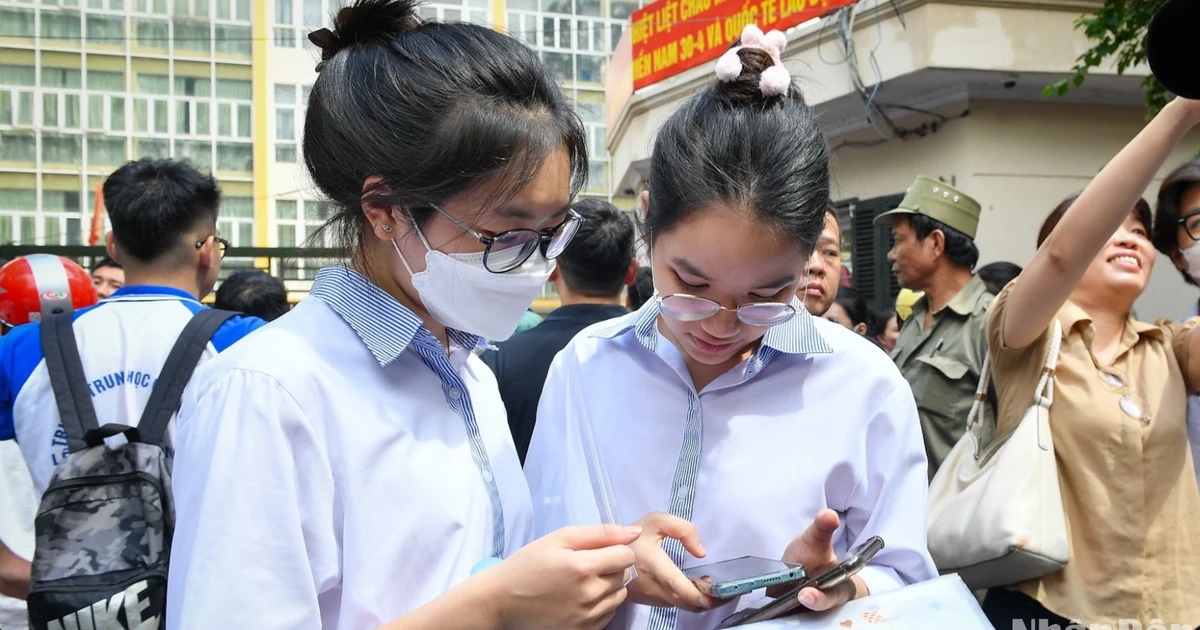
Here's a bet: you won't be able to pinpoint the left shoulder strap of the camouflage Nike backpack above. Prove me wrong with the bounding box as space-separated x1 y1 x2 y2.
41 312 103 452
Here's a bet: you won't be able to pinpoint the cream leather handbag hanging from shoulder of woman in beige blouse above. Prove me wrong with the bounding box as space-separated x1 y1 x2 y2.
929 319 1070 589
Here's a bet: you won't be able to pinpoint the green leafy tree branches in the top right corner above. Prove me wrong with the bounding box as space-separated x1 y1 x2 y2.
1043 0 1169 118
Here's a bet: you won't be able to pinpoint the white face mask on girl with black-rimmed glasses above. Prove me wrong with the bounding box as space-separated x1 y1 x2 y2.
391 213 554 341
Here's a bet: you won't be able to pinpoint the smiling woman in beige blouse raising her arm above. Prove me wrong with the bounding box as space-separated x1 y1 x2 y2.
984 100 1200 630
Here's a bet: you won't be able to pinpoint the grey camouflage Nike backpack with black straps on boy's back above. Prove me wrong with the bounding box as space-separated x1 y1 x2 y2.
28 310 234 630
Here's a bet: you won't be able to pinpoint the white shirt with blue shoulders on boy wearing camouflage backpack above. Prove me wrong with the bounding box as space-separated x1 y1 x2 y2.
0 284 265 500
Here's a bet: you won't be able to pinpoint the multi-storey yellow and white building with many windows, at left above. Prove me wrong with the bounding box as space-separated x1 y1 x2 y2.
0 0 640 301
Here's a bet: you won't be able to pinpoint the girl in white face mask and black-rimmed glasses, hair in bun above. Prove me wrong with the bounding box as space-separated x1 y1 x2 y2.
167 0 640 630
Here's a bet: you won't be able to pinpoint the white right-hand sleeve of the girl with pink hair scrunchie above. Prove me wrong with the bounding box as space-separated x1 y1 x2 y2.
845 383 937 594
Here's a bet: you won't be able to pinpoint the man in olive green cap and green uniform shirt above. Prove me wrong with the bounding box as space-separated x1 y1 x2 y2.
875 176 996 479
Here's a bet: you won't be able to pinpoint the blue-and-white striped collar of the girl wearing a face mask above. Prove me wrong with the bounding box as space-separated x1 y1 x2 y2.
310 266 484 366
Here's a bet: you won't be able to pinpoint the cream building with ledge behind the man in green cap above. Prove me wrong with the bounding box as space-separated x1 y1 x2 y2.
608 0 1200 320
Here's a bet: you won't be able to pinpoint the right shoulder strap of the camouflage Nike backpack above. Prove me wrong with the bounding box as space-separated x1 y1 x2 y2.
137 308 236 445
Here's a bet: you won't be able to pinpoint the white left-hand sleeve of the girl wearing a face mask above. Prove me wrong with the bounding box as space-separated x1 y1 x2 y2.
167 370 338 630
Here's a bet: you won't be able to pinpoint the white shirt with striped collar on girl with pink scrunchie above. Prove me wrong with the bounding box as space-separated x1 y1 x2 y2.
526 301 937 630
